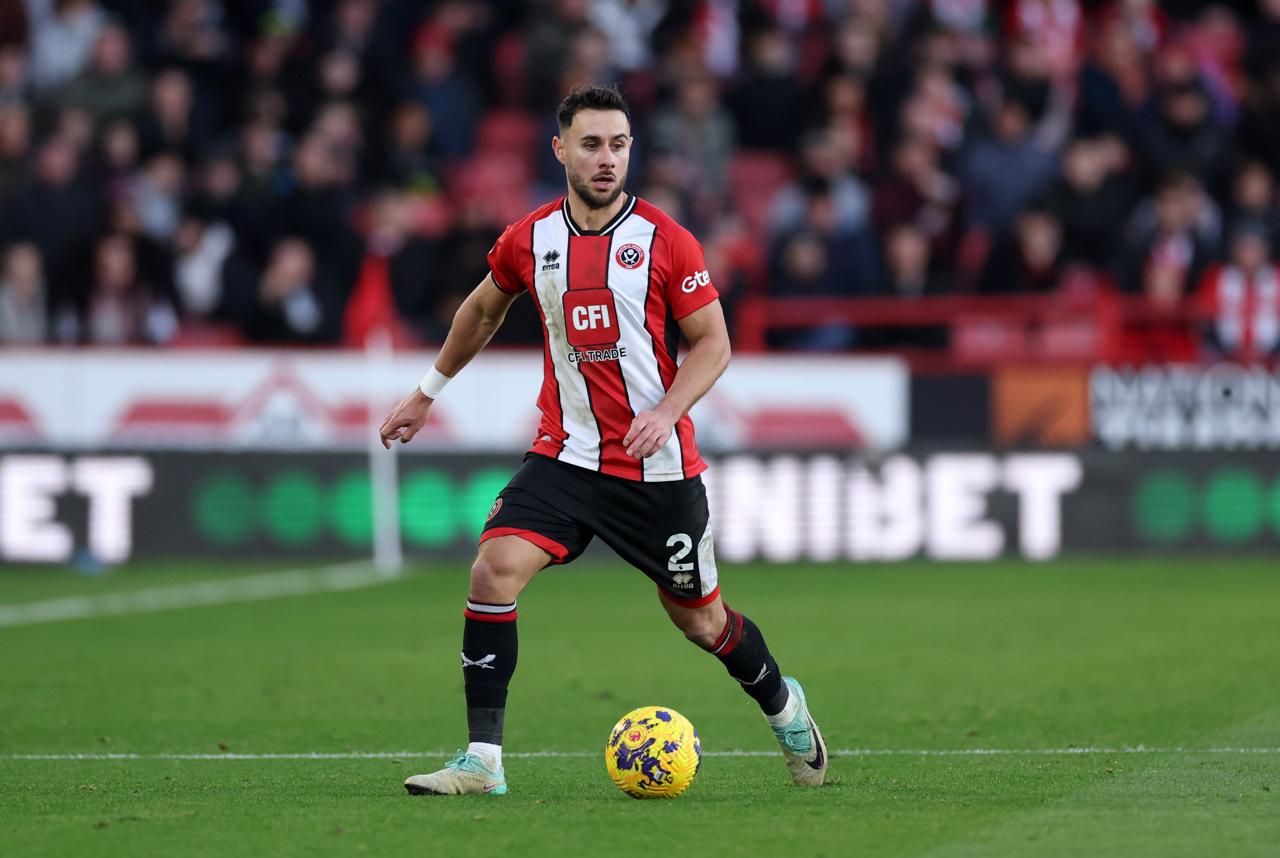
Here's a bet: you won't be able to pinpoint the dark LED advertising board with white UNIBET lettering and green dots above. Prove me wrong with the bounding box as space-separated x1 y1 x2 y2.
0 448 1280 570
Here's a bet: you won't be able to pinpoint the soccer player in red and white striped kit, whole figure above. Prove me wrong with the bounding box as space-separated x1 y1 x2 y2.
380 86 827 795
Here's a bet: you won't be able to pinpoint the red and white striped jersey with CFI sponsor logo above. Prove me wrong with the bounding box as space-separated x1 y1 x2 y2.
489 196 719 482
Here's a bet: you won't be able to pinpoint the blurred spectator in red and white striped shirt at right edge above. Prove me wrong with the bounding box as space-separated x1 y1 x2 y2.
1196 222 1280 362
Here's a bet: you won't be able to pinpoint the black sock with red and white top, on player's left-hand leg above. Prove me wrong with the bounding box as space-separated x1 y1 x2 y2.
462 601 517 745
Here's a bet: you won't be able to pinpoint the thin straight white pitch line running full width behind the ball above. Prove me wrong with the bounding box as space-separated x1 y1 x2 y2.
0 745 1280 762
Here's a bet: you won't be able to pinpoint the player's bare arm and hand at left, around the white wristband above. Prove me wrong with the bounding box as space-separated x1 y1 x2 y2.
379 274 520 449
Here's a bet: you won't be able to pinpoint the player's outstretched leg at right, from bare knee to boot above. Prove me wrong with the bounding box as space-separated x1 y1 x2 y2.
658 584 827 786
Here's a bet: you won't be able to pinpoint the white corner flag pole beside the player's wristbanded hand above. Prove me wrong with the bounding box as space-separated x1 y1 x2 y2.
365 328 403 578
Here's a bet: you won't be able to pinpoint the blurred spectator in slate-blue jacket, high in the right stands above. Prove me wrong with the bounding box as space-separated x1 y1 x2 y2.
960 89 1057 236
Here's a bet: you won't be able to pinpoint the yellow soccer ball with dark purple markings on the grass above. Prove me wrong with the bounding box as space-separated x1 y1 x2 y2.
604 706 703 798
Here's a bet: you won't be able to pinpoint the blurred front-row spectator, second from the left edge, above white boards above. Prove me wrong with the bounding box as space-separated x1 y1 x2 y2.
83 233 178 346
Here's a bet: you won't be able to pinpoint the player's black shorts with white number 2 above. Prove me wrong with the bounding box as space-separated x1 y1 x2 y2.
480 453 719 607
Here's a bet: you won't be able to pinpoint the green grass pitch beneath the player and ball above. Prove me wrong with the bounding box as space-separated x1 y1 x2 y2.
0 558 1280 858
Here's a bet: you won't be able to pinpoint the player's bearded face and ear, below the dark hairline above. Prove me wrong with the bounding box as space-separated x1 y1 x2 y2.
552 110 631 209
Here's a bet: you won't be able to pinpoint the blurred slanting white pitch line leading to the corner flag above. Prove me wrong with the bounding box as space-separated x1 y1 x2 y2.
0 561 397 629
